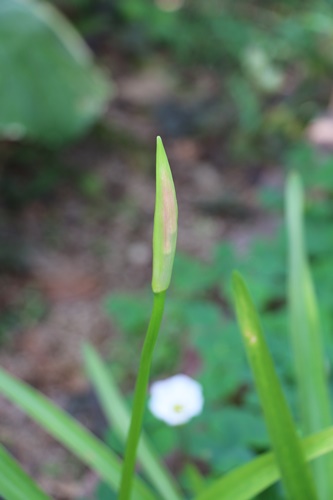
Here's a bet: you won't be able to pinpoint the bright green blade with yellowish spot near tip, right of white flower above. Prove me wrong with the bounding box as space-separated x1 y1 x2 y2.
233 272 317 500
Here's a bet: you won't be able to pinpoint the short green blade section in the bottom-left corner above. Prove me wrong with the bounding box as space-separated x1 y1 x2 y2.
0 445 51 500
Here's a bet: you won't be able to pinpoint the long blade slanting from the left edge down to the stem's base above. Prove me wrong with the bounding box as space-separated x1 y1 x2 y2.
0 369 154 500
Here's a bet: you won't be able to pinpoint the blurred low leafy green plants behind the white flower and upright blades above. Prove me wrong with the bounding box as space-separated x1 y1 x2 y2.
106 145 333 498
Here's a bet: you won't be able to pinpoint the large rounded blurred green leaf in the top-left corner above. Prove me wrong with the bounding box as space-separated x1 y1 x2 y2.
0 0 110 145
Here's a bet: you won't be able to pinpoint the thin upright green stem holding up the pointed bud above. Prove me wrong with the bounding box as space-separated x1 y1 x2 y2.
118 291 165 500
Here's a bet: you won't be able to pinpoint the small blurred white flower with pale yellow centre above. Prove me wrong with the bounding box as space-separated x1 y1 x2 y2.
148 374 204 425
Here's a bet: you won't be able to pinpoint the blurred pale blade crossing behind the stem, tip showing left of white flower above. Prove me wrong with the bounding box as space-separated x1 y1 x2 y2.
83 344 181 500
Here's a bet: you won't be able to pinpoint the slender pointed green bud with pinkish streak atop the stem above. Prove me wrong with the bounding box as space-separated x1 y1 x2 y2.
152 137 178 293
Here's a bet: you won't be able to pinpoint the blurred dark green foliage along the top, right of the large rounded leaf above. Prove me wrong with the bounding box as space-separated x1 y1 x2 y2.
57 0 333 161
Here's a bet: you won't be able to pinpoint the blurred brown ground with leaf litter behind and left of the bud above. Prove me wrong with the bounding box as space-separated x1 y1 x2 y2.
0 60 282 499
